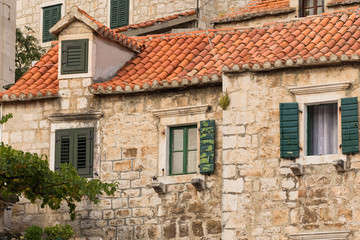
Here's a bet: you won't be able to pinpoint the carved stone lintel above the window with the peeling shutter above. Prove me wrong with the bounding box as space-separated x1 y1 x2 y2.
152 105 210 118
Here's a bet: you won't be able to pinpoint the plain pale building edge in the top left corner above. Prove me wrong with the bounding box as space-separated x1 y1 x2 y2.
0 0 16 90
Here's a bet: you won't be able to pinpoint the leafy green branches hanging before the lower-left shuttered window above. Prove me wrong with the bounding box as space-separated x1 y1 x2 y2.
0 143 117 219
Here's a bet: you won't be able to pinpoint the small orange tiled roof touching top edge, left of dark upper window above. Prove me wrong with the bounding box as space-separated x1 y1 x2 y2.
212 0 295 23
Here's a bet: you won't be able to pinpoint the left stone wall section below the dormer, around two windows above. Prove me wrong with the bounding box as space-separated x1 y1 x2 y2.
2 78 222 239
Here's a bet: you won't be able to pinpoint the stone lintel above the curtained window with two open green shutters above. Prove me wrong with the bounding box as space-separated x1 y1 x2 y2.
289 82 351 95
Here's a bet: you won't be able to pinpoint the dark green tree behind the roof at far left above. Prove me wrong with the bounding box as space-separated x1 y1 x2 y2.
15 26 45 81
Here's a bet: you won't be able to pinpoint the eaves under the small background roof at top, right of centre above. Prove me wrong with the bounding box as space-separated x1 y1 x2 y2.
211 8 296 24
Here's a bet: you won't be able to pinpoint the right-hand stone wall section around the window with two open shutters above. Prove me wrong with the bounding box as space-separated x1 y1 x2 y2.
222 66 360 240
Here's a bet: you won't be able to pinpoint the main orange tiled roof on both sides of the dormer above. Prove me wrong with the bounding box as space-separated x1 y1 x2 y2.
0 8 360 101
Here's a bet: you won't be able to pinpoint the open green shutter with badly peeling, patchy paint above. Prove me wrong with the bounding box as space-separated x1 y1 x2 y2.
199 120 215 174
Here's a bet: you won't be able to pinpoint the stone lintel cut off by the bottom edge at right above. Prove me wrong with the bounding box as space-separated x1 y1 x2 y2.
289 231 350 240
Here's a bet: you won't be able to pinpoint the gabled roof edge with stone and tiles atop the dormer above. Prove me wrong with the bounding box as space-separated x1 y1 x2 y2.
50 6 142 52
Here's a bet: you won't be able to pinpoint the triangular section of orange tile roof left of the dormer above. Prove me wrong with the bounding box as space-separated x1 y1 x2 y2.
0 44 59 100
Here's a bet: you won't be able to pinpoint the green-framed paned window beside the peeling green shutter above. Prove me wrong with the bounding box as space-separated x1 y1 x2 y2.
169 125 198 175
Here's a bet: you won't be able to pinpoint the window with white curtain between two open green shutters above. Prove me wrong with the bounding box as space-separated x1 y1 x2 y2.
307 103 338 155
